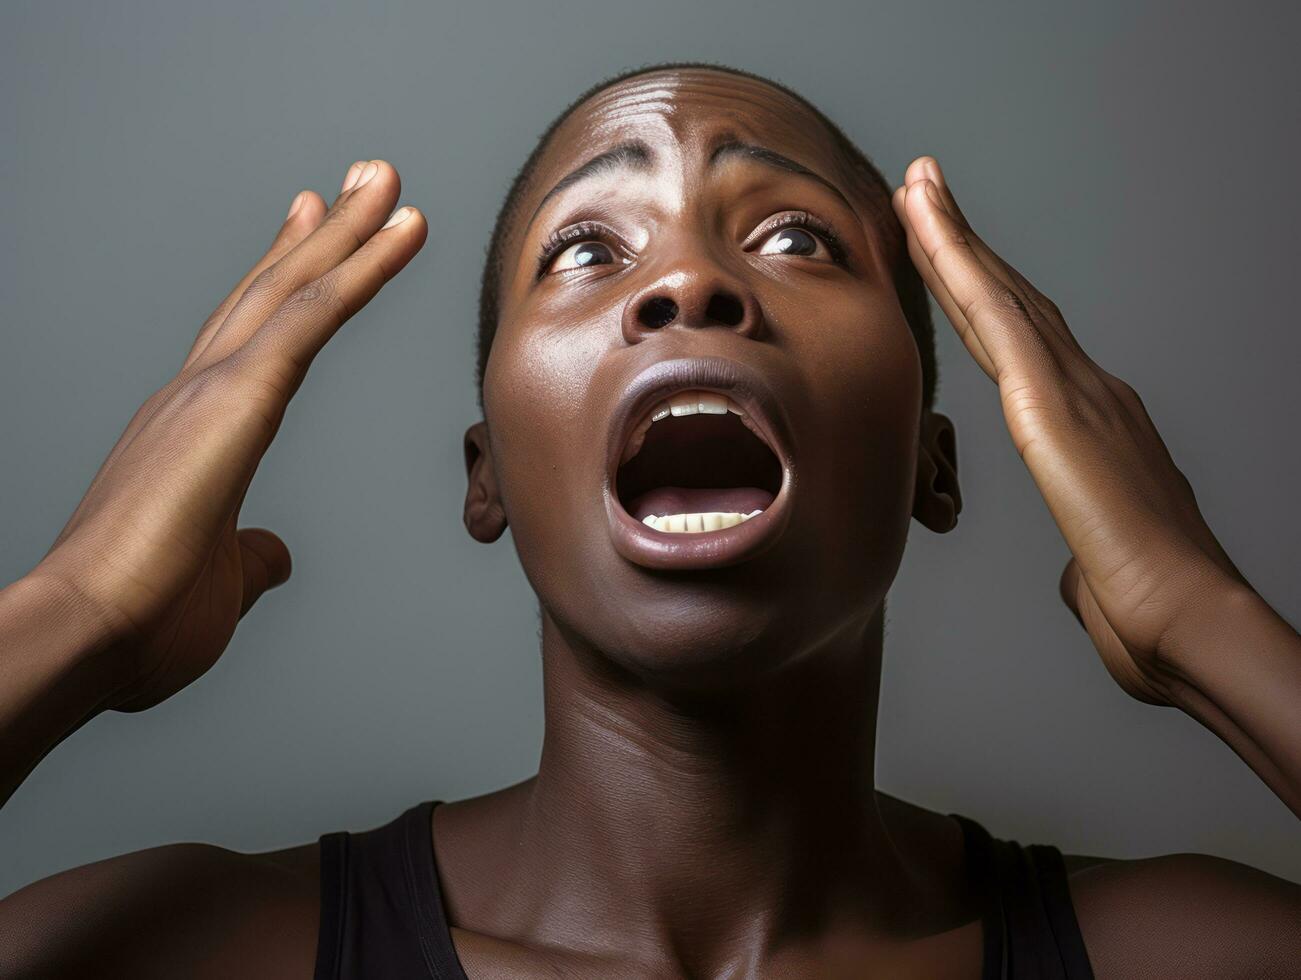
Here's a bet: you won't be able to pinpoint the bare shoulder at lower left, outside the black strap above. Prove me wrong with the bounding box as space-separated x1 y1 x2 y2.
0 842 320 980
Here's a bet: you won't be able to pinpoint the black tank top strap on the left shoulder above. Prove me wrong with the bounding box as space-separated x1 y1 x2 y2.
314 800 467 980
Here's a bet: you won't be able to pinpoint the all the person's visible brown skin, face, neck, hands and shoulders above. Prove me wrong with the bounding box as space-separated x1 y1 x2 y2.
0 70 1301 977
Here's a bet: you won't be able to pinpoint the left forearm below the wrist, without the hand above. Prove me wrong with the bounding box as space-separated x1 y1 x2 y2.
0 578 129 806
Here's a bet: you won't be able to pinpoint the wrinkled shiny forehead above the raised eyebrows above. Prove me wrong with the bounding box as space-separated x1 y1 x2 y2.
522 69 876 212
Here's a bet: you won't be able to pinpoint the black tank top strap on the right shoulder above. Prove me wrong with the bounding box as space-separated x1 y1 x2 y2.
950 813 1093 980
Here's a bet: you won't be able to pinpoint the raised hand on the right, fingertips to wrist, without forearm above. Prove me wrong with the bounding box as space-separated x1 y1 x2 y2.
894 156 1246 704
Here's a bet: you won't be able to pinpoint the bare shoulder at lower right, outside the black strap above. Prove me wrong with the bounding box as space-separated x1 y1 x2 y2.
1066 854 1301 980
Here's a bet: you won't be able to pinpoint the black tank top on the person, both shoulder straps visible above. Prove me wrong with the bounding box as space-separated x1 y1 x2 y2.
315 800 1093 980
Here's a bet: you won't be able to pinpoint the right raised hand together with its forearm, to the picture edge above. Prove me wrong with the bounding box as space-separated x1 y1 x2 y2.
894 157 1301 815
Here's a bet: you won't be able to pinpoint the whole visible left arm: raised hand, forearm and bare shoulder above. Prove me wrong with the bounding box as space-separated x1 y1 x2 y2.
0 154 425 977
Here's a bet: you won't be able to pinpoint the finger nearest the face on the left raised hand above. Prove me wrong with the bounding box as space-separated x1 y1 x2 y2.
232 206 428 390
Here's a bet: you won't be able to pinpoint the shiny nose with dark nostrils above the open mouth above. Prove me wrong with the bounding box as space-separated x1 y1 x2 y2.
623 269 764 344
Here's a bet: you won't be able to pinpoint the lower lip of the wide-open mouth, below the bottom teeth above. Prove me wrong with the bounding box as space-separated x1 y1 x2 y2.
605 471 791 571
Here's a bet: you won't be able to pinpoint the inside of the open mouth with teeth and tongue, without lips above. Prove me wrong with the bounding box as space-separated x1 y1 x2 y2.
615 390 782 534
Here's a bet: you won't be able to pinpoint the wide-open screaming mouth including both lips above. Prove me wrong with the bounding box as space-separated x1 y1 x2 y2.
606 357 795 570
